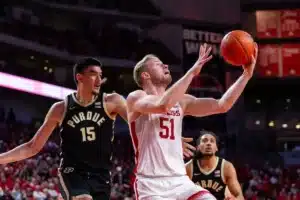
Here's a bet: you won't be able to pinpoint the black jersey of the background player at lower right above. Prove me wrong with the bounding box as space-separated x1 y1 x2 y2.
192 157 226 199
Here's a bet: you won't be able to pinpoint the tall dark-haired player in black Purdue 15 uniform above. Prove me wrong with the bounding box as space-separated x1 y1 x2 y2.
0 58 126 200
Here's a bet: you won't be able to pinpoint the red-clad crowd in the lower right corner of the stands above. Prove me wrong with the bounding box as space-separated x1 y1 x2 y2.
238 162 300 200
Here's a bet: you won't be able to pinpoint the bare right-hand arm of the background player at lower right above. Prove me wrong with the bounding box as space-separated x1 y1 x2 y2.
223 161 244 200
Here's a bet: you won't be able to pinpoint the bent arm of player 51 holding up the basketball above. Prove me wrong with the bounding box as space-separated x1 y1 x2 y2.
181 45 257 117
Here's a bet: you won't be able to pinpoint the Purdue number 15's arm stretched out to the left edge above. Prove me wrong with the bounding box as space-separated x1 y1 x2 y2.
0 102 64 164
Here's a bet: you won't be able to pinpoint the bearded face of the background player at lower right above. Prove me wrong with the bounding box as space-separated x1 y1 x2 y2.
197 134 218 156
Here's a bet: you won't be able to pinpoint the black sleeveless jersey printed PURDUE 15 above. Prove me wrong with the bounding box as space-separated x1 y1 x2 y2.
60 93 114 171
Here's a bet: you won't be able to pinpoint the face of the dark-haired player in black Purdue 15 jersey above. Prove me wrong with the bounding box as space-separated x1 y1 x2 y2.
78 66 102 95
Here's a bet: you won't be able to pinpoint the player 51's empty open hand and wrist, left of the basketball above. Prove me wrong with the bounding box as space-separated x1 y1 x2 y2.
190 43 212 76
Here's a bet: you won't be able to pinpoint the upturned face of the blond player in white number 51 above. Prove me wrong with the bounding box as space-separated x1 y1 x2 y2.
147 58 172 85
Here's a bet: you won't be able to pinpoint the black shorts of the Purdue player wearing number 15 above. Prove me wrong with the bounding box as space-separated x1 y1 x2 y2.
58 167 111 200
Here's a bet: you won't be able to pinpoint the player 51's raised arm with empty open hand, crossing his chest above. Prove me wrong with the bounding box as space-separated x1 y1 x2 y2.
127 44 212 113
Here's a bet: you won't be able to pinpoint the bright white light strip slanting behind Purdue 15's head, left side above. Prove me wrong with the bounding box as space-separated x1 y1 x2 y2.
0 72 75 100
